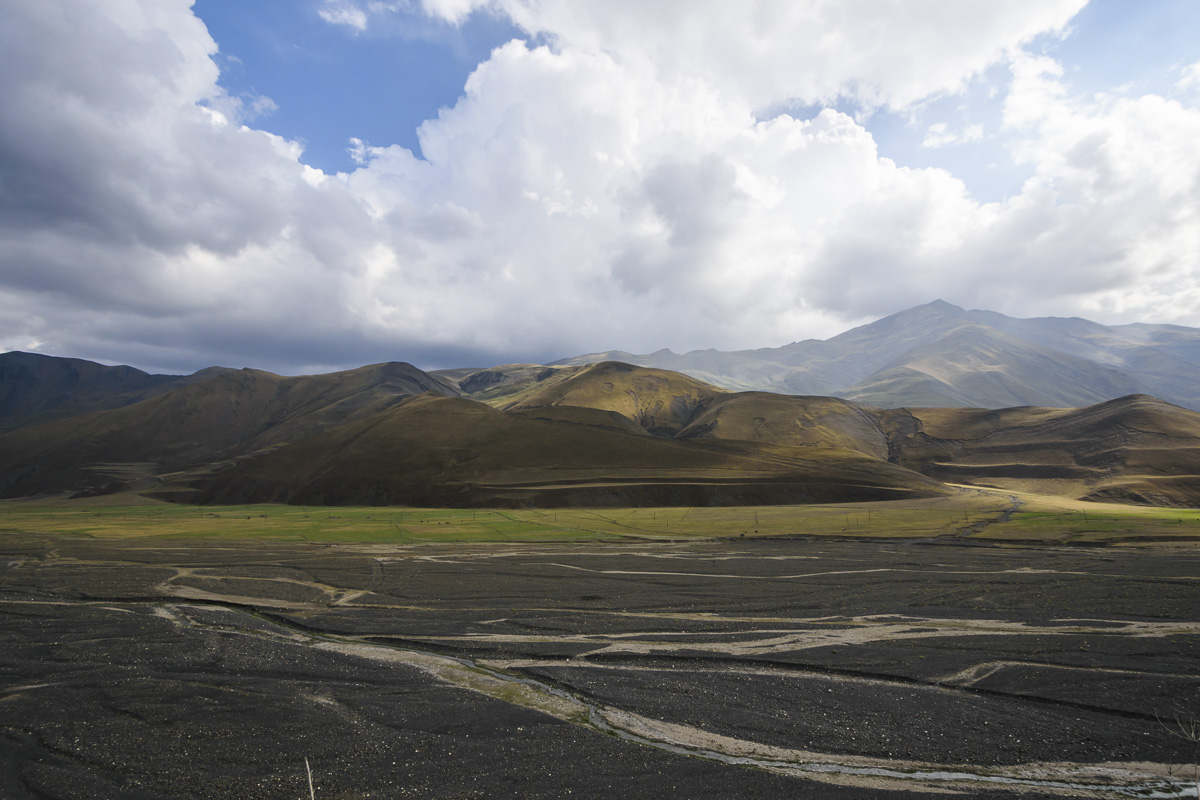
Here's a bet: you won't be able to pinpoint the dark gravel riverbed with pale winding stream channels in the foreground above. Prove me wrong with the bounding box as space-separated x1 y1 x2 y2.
0 531 1200 800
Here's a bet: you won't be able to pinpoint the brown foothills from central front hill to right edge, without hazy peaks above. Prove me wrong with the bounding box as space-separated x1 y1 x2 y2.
193 371 1200 507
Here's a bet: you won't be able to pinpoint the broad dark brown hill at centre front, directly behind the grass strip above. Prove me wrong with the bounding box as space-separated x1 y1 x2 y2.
200 396 944 506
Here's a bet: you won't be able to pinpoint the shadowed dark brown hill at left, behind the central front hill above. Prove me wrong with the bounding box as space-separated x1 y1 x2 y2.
0 363 457 497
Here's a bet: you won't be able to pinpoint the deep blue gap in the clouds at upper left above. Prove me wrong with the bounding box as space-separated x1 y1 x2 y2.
193 0 521 173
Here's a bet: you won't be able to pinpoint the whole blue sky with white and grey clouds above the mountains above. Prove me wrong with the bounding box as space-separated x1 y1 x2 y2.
0 0 1200 374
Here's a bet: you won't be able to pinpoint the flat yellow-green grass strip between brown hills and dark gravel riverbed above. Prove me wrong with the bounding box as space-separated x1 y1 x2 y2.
9 487 1200 545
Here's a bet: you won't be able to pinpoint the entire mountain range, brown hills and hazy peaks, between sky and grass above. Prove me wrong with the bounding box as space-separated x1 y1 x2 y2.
7 301 1200 507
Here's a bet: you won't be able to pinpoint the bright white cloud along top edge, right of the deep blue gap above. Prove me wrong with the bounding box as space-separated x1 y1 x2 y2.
338 0 1087 109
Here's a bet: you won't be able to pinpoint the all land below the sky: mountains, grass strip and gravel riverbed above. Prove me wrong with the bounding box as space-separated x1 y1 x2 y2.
7 303 1200 800
